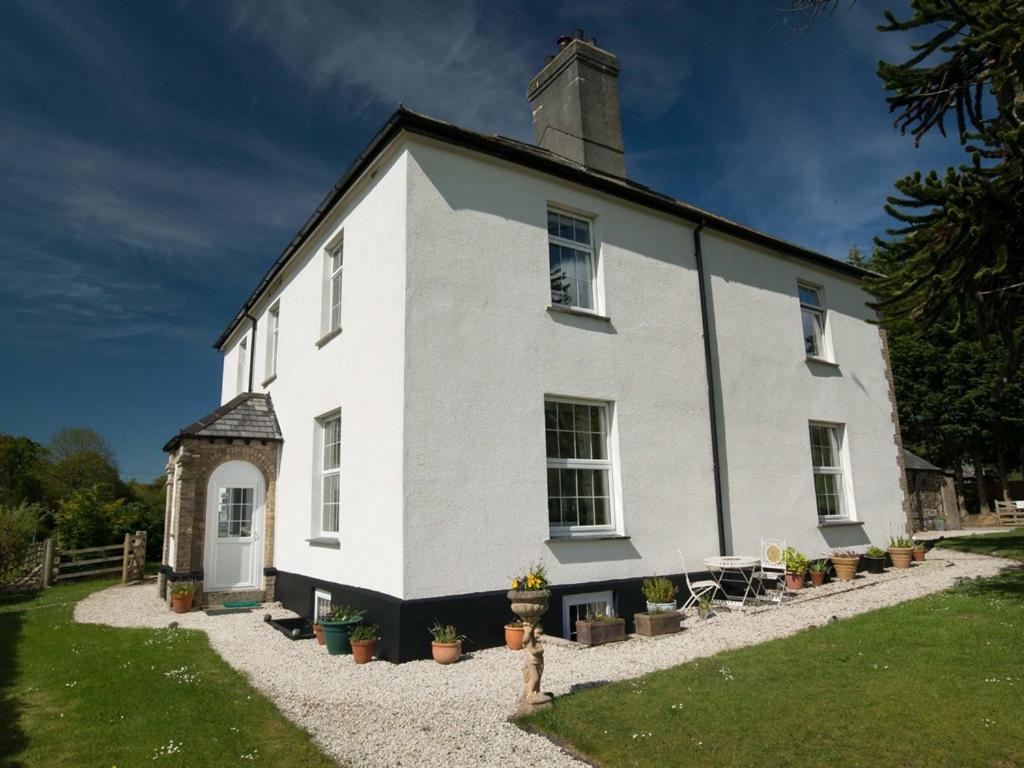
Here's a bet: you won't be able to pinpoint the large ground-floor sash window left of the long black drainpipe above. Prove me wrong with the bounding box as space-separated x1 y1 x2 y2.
544 399 613 535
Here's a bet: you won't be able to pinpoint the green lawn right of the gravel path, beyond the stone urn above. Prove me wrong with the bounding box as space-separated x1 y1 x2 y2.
523 529 1024 768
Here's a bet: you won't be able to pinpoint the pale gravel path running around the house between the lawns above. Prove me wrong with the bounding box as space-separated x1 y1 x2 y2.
75 550 1016 768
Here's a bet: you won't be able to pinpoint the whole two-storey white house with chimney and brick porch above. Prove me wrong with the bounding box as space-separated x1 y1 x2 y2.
164 34 906 660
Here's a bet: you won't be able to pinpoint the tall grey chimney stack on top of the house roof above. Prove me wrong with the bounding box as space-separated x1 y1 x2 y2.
526 30 626 176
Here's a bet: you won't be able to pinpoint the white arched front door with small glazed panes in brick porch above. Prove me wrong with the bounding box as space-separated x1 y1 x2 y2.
204 461 264 592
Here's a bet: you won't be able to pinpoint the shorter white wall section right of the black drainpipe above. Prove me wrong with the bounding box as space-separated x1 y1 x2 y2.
702 229 905 556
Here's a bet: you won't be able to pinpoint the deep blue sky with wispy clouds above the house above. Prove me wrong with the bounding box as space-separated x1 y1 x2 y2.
0 0 957 478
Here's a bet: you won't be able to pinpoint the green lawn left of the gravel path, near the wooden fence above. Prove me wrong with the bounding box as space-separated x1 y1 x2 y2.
0 582 335 768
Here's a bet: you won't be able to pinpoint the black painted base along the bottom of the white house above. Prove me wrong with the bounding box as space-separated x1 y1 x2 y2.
275 570 729 663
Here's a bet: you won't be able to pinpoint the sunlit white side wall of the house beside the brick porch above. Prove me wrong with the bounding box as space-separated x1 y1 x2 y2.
221 145 407 596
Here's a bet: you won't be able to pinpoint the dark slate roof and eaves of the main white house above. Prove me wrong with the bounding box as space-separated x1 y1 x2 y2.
213 105 878 349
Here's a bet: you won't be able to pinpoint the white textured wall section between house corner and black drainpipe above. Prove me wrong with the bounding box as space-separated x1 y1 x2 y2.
404 139 718 598
